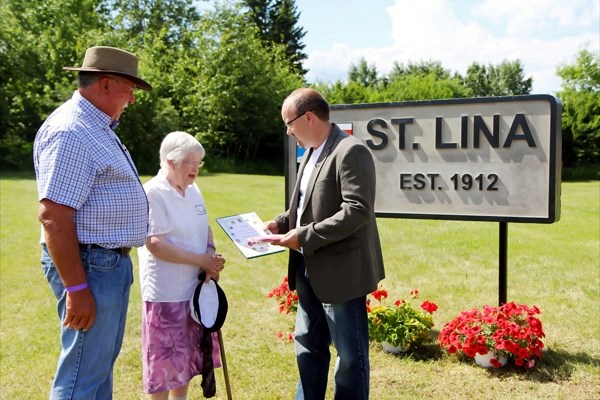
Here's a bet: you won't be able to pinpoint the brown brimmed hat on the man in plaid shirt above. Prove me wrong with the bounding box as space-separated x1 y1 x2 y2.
63 46 152 90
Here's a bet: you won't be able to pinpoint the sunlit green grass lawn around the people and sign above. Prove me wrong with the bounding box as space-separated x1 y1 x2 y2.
0 174 600 400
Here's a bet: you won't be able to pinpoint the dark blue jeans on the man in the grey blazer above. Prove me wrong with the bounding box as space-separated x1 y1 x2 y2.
294 260 370 400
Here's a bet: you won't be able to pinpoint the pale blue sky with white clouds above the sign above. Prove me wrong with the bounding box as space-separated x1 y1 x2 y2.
296 0 600 94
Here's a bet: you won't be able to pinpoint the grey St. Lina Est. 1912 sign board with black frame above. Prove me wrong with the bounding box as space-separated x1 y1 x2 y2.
292 95 562 223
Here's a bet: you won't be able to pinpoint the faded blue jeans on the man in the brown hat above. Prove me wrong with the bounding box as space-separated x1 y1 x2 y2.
42 246 133 400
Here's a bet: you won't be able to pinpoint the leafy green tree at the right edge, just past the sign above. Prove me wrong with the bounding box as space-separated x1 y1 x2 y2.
556 48 600 166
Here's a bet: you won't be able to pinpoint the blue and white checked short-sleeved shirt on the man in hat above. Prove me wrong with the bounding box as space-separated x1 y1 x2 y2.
33 91 148 248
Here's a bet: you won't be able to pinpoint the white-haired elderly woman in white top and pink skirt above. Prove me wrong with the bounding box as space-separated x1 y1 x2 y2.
138 132 225 399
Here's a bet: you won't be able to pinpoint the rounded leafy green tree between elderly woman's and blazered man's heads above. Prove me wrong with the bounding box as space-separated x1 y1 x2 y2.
173 4 302 162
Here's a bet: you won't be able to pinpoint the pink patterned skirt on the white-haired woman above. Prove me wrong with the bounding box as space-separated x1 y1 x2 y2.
142 301 221 393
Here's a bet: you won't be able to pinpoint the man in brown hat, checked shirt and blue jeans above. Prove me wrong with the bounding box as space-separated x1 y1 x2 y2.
33 46 152 400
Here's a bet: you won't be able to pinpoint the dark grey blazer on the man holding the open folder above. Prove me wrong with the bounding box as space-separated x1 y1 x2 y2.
275 124 385 303
